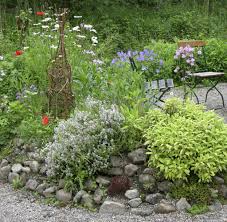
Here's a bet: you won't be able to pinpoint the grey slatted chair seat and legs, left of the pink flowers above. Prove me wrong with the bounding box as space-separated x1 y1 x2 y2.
145 79 174 107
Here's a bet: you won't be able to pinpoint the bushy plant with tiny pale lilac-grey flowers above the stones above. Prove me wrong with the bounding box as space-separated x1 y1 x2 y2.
43 97 124 184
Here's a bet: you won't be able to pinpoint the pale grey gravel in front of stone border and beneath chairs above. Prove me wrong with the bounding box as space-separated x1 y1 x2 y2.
0 83 227 222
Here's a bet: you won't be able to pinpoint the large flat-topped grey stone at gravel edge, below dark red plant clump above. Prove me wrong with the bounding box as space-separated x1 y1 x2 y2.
99 200 126 215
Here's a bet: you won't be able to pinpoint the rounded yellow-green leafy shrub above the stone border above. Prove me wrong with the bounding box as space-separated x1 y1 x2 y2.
137 98 227 182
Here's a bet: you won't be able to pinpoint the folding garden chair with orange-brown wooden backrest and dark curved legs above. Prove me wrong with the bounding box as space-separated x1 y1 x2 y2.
178 40 225 107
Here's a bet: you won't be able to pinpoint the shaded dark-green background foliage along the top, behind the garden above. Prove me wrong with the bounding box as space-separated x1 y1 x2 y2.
0 0 227 54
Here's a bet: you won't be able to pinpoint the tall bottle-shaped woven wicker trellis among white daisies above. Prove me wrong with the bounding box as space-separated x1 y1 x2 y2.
48 9 74 118
